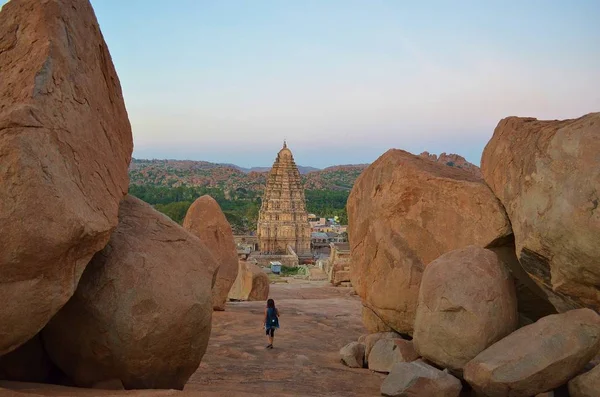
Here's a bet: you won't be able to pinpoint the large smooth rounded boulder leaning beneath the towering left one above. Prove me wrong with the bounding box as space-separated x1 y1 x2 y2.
42 196 216 389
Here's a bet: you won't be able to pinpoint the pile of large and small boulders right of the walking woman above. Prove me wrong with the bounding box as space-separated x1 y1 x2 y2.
340 113 600 397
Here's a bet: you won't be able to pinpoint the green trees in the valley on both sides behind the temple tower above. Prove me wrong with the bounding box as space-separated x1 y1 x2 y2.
129 184 349 234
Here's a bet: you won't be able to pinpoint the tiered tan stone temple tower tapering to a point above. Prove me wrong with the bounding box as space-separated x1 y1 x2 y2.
257 142 310 256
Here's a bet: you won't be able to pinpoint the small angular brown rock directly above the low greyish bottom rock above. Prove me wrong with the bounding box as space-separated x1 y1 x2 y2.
367 338 419 373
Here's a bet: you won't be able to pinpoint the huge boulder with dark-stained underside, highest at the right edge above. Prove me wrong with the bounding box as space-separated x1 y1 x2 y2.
481 113 600 311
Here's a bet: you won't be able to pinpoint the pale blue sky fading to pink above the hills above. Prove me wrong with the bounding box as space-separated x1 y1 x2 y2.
0 0 600 167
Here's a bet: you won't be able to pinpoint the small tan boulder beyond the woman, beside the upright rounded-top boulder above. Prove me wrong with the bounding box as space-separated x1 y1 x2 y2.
229 261 270 301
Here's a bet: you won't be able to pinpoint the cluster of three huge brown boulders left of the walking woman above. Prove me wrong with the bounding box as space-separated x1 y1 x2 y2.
0 0 238 389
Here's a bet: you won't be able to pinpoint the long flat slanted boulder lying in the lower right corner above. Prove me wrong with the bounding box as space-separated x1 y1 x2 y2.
464 309 600 397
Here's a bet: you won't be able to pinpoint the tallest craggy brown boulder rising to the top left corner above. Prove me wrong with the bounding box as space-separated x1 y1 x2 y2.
0 0 132 355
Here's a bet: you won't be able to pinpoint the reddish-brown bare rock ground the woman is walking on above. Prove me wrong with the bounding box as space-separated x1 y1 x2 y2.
185 282 383 396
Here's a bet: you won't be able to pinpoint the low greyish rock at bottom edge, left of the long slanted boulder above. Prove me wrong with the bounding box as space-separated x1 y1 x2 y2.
381 361 462 397
